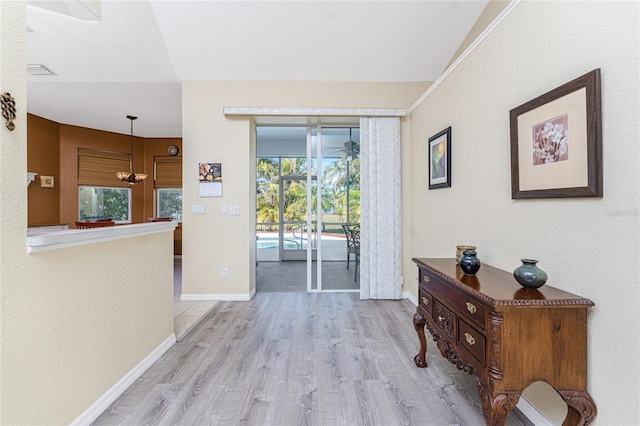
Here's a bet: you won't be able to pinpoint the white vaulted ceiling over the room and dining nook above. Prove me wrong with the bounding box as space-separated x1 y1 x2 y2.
27 0 487 137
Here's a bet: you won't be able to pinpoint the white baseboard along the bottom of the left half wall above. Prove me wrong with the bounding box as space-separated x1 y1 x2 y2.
71 334 176 425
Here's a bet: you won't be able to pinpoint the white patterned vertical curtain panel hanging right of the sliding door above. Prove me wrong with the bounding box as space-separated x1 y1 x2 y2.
360 117 402 299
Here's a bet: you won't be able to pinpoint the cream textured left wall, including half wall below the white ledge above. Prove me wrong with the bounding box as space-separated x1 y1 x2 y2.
0 1 173 424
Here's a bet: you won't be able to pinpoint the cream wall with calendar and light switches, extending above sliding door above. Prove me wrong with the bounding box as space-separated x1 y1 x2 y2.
182 81 428 300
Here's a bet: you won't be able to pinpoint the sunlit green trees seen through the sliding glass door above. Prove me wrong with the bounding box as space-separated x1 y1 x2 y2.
256 158 360 231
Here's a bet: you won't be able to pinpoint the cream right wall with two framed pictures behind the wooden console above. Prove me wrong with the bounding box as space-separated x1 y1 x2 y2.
403 1 640 425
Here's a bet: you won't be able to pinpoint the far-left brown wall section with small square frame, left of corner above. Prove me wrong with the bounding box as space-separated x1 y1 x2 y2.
25 115 61 226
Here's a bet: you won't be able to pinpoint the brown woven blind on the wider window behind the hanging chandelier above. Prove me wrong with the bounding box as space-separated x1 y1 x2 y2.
78 148 131 188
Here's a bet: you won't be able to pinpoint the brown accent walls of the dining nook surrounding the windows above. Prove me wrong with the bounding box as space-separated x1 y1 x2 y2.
25 114 182 254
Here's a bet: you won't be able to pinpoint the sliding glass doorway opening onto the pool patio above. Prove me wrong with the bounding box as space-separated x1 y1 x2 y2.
256 125 360 292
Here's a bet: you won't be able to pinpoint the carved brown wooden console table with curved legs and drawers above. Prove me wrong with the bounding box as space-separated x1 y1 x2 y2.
412 259 597 425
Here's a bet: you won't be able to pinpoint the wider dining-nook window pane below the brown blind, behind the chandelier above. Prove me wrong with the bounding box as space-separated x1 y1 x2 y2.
78 186 131 223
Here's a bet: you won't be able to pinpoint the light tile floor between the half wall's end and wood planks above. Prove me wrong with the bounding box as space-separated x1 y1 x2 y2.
173 256 219 341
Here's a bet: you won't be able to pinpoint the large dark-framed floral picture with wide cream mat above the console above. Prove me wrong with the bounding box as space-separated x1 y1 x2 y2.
509 69 602 199
